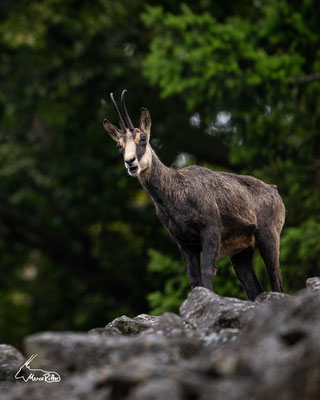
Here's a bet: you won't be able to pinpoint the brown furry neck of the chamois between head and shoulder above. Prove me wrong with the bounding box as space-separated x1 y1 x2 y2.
139 149 174 204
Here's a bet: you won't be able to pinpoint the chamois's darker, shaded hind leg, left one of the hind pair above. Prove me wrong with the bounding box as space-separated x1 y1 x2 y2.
230 247 263 301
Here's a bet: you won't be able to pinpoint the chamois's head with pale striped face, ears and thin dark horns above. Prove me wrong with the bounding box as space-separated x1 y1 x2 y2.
103 90 152 176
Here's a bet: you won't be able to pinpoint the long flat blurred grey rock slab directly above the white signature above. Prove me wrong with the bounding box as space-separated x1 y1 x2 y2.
24 332 199 374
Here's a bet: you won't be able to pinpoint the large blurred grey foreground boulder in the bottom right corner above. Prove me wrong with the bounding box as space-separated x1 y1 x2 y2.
206 295 320 399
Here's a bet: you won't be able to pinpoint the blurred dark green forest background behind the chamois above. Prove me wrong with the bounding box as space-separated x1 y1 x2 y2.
0 0 320 345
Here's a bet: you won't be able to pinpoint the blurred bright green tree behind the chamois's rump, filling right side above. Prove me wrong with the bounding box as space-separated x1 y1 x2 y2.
143 0 320 304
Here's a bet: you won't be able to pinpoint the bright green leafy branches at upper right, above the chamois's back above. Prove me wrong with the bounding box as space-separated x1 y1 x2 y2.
144 2 304 105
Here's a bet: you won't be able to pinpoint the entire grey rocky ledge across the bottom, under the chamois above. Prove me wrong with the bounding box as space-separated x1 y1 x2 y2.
0 278 320 400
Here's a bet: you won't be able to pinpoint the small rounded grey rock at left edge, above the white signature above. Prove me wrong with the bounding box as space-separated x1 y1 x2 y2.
0 344 26 382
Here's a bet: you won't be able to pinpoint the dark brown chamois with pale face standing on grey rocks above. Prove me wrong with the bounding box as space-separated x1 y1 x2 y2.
103 90 285 300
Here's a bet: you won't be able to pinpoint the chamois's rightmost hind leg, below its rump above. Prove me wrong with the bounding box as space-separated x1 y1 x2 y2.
255 228 283 292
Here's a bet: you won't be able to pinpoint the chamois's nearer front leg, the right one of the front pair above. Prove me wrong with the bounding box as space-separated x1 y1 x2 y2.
201 229 220 290
